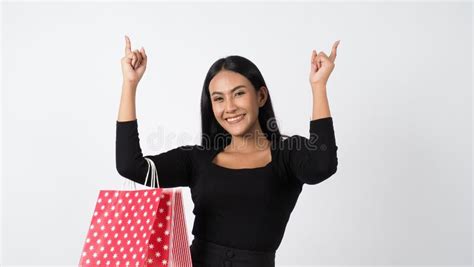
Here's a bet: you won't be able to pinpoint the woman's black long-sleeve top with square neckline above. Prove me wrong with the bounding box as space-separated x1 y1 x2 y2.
116 117 338 252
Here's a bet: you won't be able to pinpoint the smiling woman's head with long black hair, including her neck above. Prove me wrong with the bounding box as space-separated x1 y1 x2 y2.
201 55 288 154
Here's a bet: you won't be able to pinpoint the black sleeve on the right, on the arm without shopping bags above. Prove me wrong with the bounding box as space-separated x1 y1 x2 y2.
283 117 338 185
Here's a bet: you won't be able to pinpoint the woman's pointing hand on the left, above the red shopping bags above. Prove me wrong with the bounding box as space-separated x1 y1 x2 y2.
121 36 147 86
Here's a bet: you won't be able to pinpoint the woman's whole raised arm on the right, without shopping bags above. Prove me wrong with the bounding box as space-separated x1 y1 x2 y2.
284 41 339 184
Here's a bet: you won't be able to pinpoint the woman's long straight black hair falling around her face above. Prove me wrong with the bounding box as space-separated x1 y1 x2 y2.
201 55 288 149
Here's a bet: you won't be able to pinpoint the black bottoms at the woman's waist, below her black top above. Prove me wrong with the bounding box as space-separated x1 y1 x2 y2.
190 238 275 267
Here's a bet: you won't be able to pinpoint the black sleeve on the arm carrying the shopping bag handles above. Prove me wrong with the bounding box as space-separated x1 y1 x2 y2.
115 119 196 188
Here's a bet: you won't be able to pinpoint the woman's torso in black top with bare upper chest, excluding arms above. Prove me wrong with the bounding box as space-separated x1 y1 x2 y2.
190 138 302 251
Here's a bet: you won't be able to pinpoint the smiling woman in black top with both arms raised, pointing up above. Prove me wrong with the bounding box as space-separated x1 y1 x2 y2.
116 36 339 267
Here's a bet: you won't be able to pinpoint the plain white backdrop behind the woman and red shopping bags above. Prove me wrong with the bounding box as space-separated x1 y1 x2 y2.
0 2 473 266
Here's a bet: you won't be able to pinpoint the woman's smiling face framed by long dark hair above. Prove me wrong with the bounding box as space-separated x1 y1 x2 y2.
209 70 267 136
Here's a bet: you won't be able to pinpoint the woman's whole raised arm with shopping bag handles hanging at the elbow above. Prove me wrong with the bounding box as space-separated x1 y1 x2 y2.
115 36 195 188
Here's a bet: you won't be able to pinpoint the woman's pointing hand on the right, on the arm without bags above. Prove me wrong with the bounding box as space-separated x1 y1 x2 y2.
309 40 339 87
